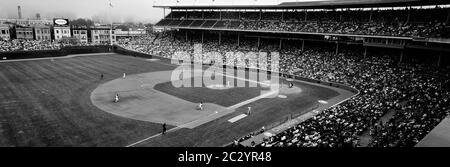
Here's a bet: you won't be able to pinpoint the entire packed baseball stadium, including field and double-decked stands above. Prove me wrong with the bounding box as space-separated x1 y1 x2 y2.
0 0 450 147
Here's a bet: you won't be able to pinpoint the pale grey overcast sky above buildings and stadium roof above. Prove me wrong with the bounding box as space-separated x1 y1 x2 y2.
0 0 324 23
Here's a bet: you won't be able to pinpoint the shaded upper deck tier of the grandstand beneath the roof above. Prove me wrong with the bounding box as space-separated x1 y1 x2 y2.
156 5 450 38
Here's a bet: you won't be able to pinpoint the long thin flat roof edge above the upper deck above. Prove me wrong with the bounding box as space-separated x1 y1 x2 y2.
154 0 450 9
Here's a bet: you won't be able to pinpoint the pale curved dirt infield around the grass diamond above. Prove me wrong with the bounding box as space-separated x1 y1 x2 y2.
91 71 223 128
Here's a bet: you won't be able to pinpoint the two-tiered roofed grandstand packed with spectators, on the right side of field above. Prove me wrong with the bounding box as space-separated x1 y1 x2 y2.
146 0 450 147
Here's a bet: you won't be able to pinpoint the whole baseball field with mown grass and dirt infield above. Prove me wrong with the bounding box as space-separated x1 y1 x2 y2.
0 54 351 147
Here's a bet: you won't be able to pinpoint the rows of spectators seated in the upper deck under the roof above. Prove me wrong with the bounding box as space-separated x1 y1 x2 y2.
163 7 450 38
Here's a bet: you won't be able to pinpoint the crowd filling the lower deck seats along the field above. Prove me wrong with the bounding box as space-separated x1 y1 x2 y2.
120 33 450 147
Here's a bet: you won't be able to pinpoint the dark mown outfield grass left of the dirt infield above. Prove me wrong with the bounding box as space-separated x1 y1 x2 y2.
0 55 174 146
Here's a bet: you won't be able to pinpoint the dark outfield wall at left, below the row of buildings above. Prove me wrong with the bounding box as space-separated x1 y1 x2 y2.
0 45 111 61
